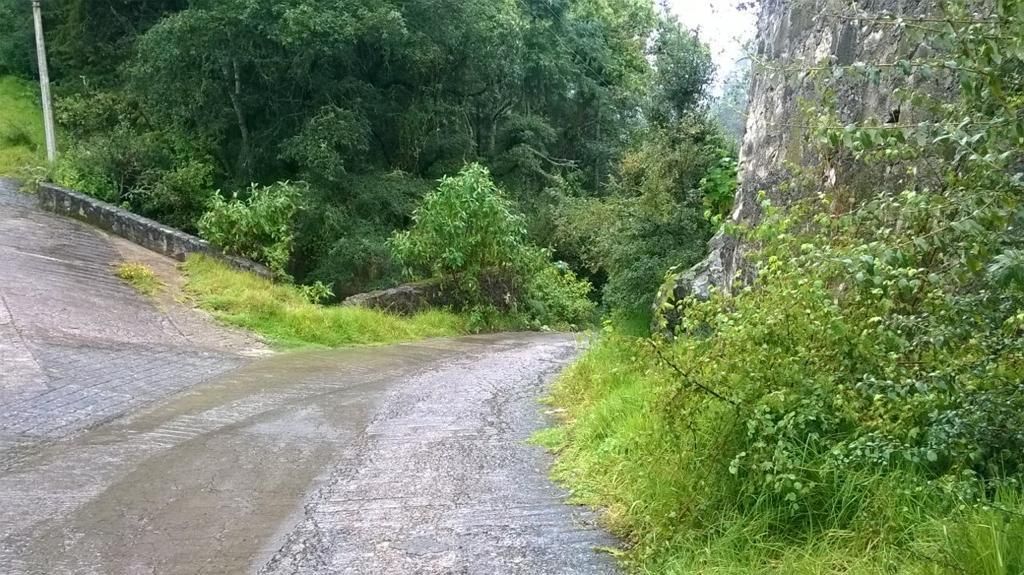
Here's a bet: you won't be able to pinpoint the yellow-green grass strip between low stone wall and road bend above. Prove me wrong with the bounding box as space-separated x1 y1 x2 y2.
182 256 469 348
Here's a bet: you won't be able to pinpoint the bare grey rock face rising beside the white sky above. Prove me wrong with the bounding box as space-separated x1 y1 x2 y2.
655 0 933 324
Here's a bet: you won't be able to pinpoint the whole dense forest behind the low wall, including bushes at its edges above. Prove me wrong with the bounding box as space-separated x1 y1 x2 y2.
0 0 736 323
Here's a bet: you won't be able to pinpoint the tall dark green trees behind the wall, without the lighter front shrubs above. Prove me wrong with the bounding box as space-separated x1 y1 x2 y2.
34 0 711 304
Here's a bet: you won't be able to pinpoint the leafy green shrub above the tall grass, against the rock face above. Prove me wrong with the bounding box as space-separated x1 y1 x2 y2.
655 184 1024 517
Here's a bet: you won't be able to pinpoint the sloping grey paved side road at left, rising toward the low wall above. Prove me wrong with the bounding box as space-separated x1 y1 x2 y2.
0 179 260 444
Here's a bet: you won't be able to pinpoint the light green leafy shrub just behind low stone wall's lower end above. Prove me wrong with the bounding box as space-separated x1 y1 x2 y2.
199 182 305 277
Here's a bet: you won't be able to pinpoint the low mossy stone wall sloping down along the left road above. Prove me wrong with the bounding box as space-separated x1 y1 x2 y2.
37 183 272 277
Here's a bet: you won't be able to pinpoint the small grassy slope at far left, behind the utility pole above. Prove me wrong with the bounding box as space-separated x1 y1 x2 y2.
0 76 45 176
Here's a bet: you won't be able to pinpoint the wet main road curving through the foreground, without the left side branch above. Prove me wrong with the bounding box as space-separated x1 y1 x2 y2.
0 334 614 574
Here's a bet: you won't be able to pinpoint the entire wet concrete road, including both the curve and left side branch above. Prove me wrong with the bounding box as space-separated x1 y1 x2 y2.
0 178 615 575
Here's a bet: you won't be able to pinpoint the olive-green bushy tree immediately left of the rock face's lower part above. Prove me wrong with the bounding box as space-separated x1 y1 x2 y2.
556 117 735 313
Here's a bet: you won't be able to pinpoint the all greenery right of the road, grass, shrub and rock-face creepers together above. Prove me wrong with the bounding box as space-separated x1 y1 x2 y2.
546 0 1024 574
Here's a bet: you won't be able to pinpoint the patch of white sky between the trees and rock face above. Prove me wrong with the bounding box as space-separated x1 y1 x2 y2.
667 0 757 84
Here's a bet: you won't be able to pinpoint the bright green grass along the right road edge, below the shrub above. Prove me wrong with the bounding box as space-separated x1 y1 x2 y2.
534 329 1024 575
